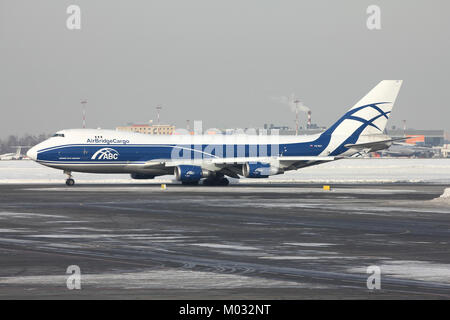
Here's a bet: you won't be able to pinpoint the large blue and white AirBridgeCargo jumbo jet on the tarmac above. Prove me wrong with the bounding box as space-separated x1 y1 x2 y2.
27 80 402 186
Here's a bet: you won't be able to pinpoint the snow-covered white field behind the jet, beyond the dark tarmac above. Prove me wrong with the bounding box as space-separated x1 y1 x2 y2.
0 159 450 184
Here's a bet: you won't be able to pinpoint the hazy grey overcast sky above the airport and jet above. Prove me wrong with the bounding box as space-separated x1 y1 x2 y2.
0 0 450 138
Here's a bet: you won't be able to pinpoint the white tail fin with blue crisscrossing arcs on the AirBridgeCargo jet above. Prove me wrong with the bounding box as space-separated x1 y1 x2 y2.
324 80 402 155
